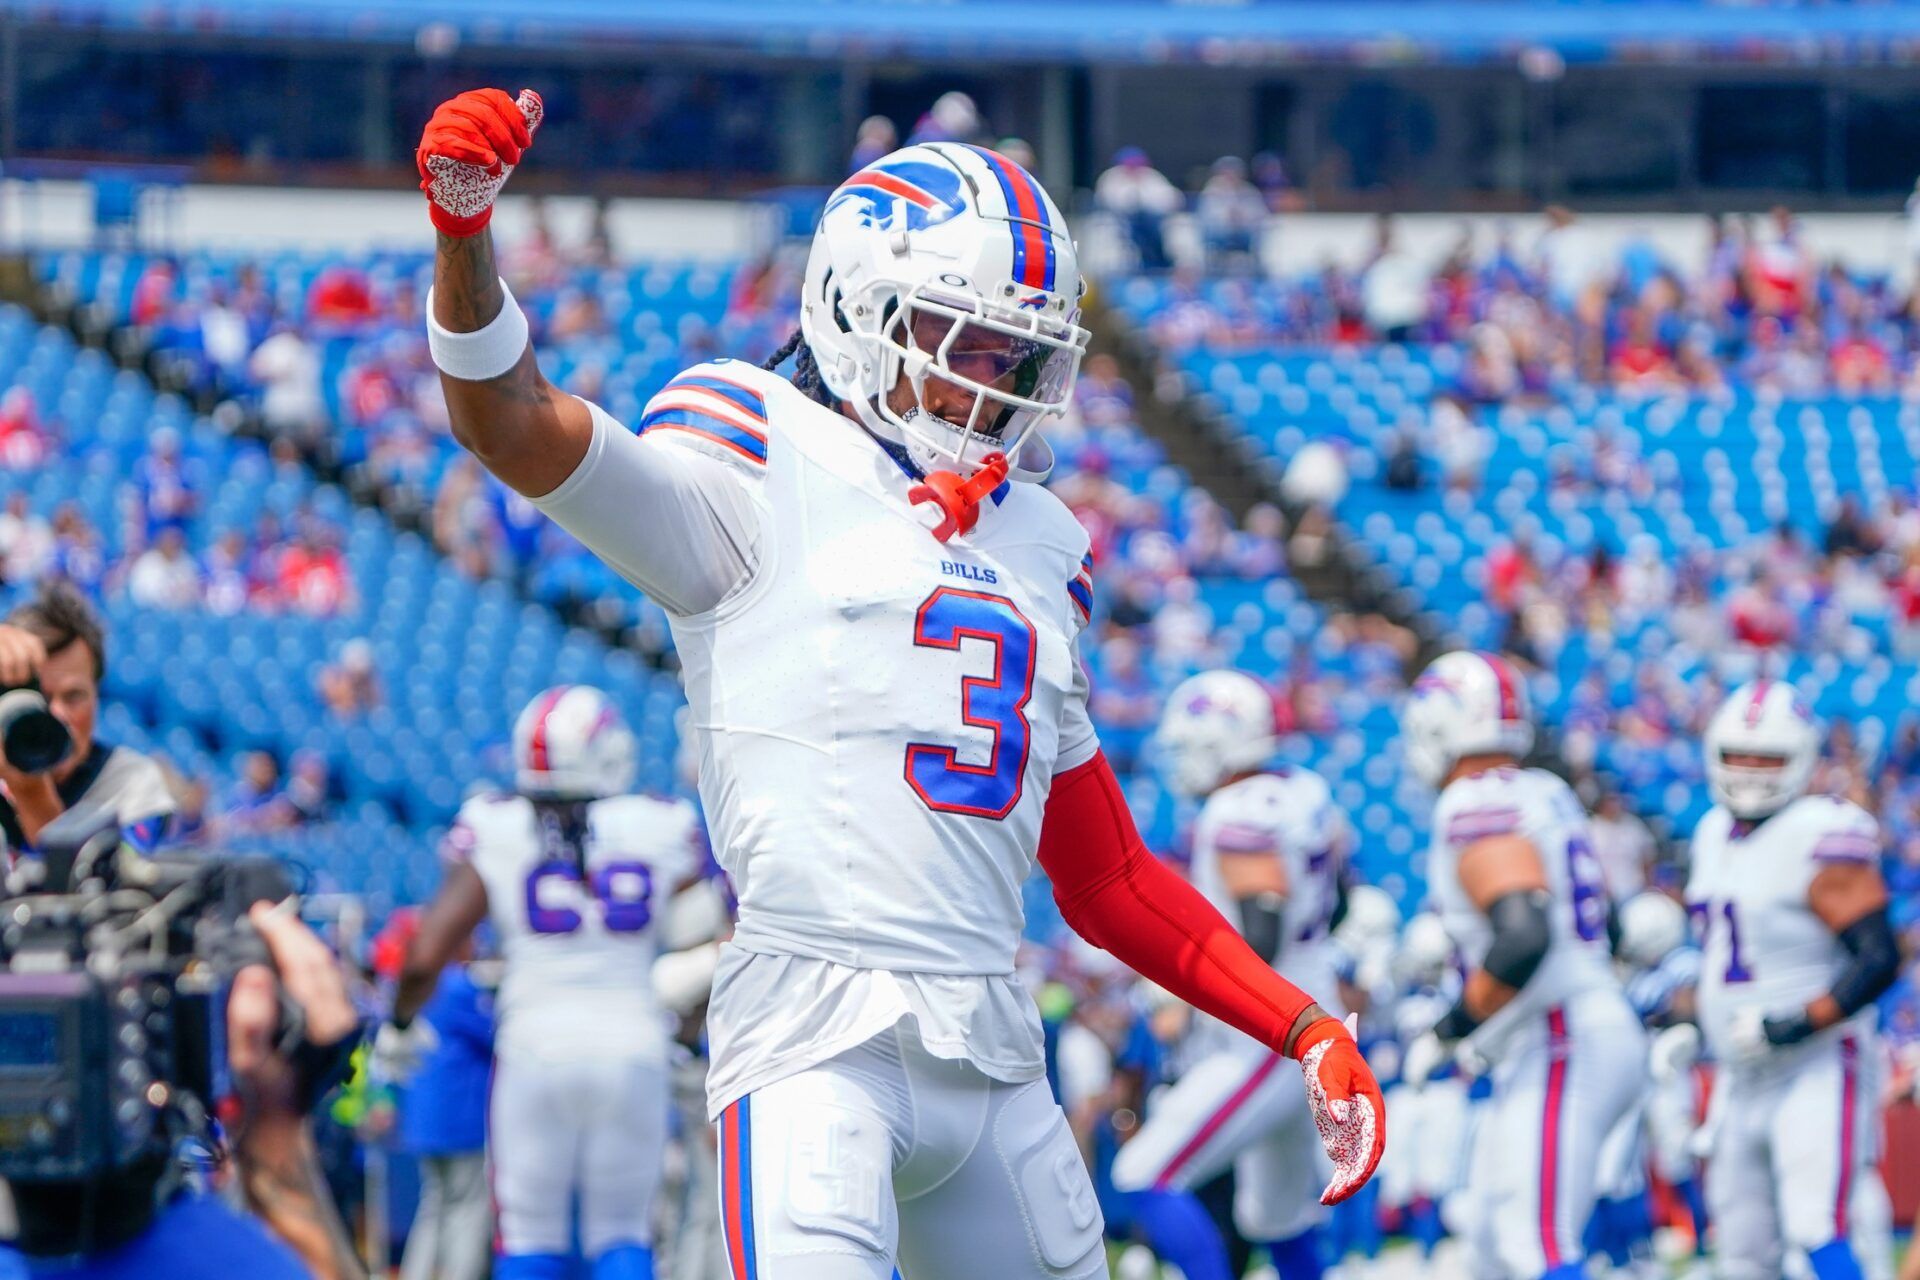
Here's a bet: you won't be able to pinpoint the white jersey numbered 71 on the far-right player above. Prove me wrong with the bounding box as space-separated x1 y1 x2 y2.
1686 796 1880 1061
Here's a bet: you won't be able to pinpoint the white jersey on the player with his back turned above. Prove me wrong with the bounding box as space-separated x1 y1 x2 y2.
444 794 701 1054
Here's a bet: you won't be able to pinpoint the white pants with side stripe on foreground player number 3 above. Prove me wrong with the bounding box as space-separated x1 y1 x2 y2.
720 1021 1106 1280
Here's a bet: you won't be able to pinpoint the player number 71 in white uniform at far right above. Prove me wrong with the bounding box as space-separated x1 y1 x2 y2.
1686 679 1899 1280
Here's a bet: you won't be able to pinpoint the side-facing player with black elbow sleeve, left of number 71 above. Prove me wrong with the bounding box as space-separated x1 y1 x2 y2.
1402 652 1647 1280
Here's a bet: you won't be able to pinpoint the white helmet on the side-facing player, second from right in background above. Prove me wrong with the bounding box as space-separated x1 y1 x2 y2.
1400 649 1534 787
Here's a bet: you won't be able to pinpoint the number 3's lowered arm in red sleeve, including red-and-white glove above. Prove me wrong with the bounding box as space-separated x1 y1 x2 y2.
1039 752 1386 1203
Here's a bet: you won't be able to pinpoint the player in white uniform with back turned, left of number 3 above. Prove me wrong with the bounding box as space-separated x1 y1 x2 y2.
376 685 701 1280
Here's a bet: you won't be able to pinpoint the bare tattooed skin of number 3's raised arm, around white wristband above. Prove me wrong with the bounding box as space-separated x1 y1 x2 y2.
434 228 593 497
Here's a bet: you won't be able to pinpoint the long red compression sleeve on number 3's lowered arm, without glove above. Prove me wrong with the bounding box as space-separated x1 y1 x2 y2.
1041 754 1313 1050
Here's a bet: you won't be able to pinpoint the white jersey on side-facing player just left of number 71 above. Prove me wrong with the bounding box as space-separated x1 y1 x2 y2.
1427 768 1624 1057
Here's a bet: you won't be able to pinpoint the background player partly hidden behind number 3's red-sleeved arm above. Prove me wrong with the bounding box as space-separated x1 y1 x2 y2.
1114 672 1348 1280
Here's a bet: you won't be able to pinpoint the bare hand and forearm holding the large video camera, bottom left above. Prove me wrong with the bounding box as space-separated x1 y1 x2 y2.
227 902 367 1280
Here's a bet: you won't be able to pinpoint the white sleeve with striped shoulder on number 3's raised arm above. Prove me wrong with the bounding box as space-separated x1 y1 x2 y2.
534 365 766 618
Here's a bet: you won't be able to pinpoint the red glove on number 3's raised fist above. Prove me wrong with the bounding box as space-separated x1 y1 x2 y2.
413 88 545 236
